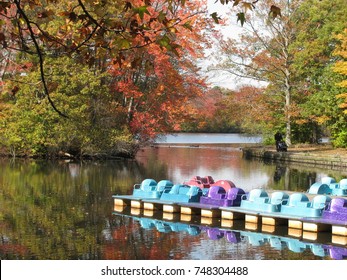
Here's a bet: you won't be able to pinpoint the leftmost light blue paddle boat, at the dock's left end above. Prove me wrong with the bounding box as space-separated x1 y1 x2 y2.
133 179 173 198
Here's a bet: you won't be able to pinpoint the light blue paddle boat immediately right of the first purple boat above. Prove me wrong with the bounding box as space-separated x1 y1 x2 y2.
240 189 289 213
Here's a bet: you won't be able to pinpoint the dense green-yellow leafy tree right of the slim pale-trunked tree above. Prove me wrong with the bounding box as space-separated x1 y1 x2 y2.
291 0 347 147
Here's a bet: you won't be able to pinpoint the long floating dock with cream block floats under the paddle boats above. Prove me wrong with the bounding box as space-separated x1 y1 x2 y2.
113 195 347 238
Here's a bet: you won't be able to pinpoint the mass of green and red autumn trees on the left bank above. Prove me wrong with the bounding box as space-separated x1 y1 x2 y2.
1 1 220 158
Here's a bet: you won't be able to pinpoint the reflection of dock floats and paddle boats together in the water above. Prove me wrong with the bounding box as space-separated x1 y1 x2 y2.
113 207 347 260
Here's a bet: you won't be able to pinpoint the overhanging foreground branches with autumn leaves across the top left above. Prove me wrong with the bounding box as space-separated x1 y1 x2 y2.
0 0 280 116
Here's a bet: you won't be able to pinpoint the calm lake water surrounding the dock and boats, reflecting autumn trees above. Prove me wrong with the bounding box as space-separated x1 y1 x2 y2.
0 134 347 260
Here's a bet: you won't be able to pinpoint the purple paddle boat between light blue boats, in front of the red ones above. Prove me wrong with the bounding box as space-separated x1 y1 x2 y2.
200 186 245 207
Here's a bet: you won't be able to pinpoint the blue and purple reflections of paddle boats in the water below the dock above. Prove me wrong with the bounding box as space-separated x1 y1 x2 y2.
113 208 347 260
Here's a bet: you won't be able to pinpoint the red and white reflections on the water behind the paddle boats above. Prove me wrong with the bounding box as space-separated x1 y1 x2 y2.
137 146 347 191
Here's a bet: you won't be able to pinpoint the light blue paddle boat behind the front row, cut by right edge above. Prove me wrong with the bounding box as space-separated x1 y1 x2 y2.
308 177 347 196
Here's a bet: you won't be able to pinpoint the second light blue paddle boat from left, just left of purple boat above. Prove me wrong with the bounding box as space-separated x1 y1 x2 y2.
160 184 202 202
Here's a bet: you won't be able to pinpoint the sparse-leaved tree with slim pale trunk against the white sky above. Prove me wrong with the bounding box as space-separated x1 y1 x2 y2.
210 0 300 144
